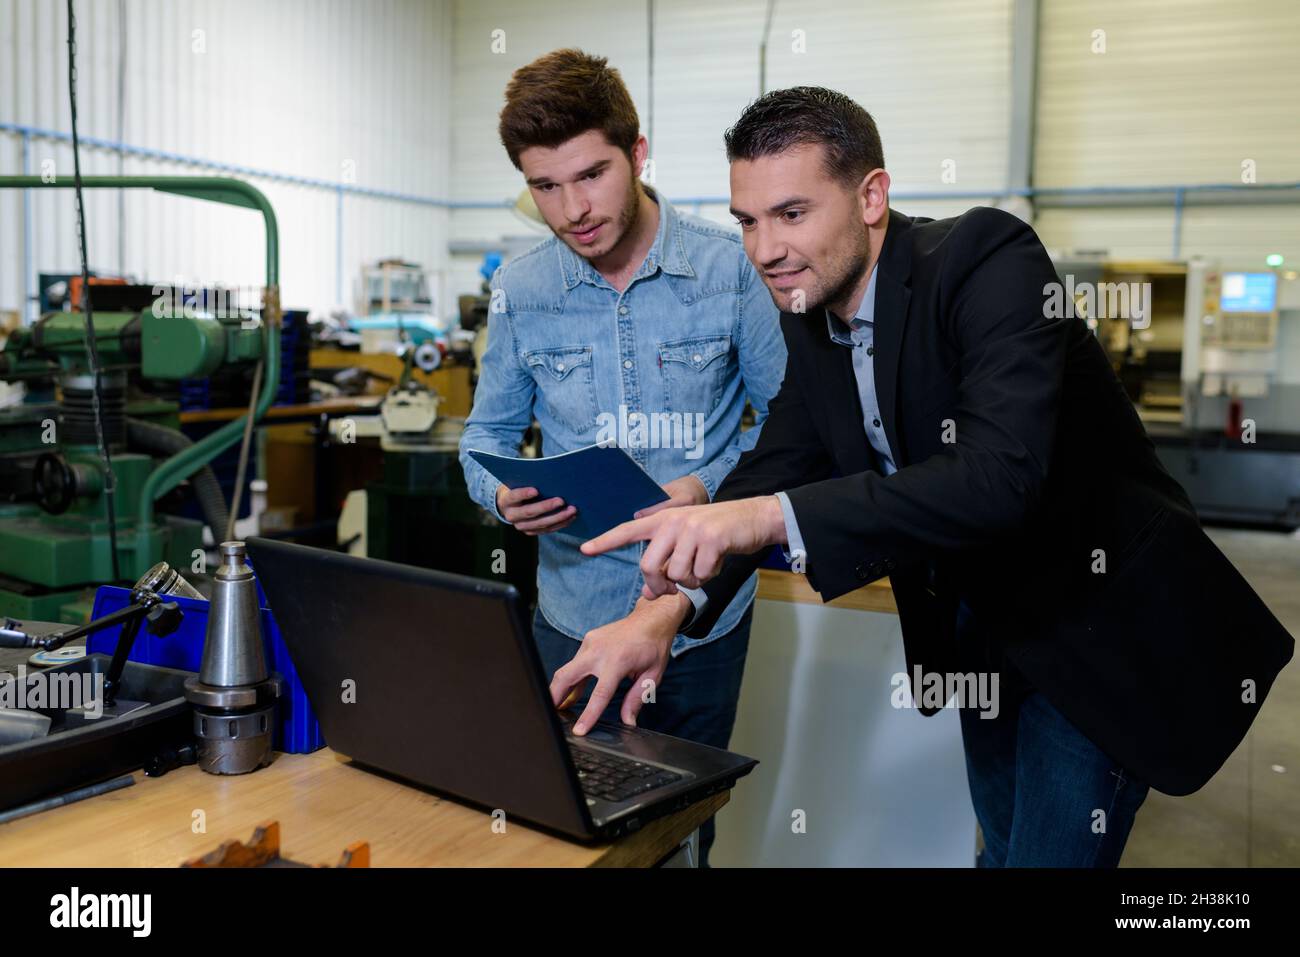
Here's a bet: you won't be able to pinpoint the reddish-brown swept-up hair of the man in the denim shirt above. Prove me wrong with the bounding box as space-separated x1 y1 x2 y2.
498 49 641 169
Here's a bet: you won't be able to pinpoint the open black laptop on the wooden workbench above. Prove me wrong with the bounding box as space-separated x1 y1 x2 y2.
247 538 758 840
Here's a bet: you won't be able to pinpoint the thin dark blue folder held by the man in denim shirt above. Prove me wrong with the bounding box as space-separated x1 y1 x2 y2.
469 445 668 540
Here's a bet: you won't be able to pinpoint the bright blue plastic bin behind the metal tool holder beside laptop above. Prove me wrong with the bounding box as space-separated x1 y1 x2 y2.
86 583 325 754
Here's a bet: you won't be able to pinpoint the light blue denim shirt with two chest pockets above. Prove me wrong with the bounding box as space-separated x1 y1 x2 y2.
460 192 785 655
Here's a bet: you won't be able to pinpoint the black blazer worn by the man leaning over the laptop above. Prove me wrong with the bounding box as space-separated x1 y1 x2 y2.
686 208 1295 794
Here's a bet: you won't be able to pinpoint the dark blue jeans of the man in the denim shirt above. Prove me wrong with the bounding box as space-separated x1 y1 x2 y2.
533 605 754 867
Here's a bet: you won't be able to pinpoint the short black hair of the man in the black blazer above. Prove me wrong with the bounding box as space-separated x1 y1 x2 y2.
723 86 885 186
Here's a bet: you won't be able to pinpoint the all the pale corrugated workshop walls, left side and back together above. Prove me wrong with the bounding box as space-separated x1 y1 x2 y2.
0 0 1300 317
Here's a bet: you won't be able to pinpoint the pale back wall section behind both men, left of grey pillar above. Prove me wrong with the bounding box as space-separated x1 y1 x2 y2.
451 0 1011 295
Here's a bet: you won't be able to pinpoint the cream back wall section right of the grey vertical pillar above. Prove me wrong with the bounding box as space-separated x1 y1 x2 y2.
1034 0 1300 267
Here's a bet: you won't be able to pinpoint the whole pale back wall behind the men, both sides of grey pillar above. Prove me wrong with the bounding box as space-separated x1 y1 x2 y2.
452 0 1300 285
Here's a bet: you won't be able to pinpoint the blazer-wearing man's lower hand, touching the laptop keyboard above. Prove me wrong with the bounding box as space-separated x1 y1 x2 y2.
551 594 692 735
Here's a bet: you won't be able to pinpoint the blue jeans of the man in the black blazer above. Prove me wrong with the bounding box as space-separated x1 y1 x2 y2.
957 602 1148 867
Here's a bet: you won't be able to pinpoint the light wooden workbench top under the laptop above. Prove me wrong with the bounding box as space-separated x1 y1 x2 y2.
0 748 729 867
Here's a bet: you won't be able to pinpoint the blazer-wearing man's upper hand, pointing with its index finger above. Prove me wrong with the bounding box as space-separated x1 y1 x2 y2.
582 495 785 599
